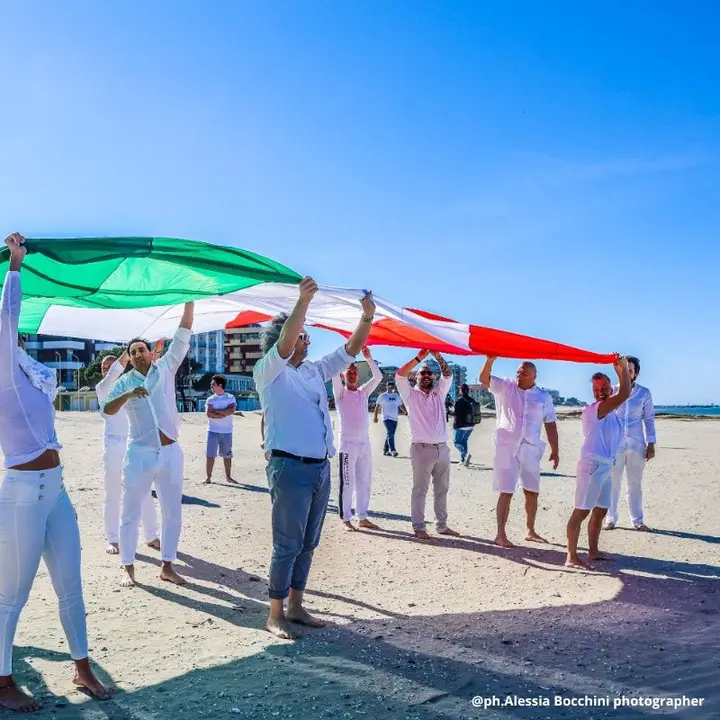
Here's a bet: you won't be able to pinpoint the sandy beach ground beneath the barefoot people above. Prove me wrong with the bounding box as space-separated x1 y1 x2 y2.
0 413 720 720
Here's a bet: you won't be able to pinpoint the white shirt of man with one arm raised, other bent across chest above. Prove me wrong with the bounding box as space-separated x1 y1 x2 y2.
101 328 192 450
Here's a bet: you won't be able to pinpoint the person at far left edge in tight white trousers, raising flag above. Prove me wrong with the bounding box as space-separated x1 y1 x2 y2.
0 233 111 712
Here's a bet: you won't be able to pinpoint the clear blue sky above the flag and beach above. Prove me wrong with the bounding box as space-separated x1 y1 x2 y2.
0 0 720 403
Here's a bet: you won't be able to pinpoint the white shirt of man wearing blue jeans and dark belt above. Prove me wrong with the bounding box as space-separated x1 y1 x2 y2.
253 344 354 460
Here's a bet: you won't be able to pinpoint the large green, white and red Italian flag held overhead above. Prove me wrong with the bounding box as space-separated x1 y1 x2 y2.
0 237 613 363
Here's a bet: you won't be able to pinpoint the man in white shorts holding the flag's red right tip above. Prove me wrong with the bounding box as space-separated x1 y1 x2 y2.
565 357 630 569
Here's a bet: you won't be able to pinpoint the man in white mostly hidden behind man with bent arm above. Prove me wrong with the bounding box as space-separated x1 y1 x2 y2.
95 352 160 555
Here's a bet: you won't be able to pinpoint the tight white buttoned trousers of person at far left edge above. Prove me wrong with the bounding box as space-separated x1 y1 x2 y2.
0 467 88 675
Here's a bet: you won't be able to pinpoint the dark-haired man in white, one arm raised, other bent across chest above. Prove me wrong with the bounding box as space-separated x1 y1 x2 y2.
102 302 195 587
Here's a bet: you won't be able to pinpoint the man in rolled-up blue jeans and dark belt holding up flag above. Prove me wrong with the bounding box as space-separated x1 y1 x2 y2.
253 277 375 640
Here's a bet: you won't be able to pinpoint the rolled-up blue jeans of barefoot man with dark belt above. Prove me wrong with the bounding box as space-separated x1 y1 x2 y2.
266 457 330 600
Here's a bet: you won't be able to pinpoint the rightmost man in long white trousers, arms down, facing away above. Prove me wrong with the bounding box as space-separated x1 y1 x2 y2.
605 355 656 532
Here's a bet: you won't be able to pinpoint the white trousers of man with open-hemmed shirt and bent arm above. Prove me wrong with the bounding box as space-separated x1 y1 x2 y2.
120 443 183 565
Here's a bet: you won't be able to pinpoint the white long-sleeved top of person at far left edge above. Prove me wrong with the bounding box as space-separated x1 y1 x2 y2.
0 270 62 468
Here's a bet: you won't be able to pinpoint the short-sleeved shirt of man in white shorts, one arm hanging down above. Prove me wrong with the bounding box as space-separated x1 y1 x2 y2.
490 375 557 452
